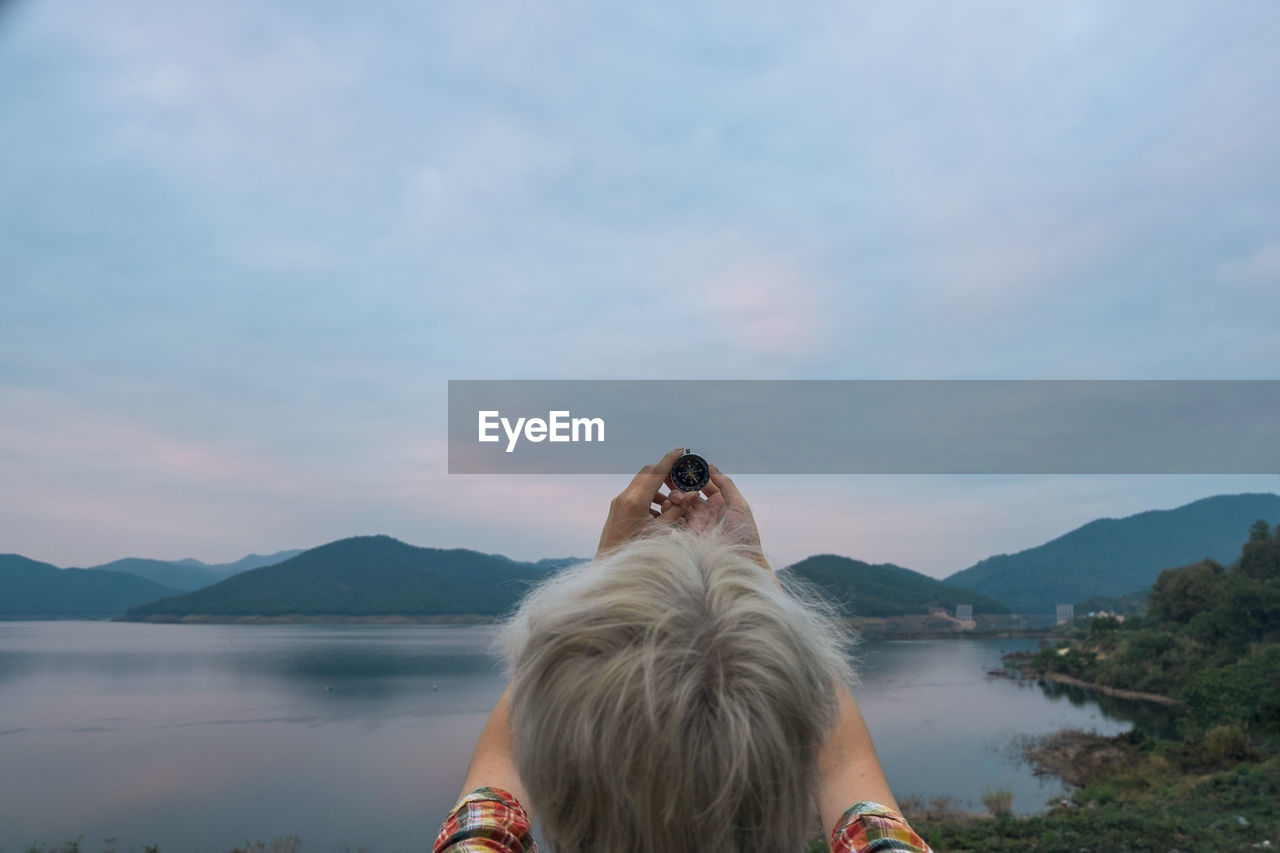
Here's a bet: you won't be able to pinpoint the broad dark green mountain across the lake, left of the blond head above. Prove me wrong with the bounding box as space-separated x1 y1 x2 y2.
125 535 563 621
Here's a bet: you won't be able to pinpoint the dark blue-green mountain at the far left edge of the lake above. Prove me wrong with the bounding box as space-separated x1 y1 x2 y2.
0 553 185 619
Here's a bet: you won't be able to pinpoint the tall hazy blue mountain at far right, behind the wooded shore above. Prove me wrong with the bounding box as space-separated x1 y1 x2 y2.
945 493 1280 613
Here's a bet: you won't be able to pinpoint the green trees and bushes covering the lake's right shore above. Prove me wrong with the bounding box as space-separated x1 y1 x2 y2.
902 521 1280 853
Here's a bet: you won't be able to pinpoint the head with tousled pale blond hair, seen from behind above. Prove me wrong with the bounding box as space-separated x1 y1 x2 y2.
499 517 852 853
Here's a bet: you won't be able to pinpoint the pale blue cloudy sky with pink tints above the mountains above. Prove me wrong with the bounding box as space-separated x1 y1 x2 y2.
0 0 1280 576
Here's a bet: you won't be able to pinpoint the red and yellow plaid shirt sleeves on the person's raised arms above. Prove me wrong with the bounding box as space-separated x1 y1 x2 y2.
431 788 932 853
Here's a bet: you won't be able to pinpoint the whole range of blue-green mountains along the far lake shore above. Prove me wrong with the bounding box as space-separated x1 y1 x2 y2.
0 494 1280 621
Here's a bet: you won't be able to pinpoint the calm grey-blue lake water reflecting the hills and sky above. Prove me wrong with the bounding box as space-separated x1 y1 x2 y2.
0 621 1157 853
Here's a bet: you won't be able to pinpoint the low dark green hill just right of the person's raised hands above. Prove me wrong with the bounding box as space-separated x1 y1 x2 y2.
785 553 1009 616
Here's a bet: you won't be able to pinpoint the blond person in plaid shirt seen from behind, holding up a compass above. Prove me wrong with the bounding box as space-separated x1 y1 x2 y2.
434 448 929 853
